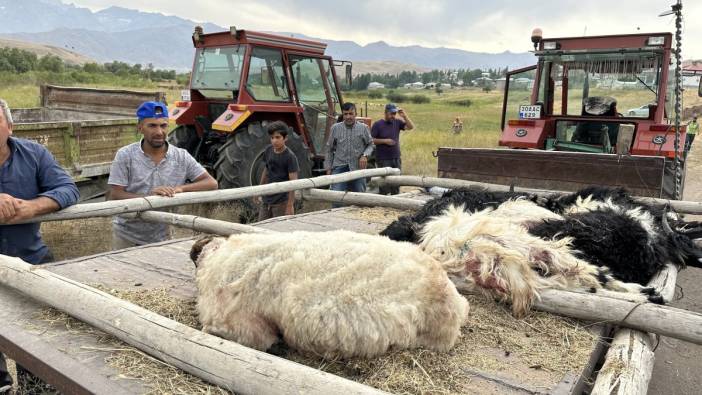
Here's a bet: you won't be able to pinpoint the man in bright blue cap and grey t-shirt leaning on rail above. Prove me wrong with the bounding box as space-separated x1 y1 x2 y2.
107 101 217 250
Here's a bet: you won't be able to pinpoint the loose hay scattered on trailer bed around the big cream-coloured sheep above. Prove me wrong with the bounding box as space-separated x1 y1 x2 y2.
26 286 598 394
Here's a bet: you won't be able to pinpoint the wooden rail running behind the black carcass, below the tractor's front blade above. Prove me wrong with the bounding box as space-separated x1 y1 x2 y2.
374 176 702 214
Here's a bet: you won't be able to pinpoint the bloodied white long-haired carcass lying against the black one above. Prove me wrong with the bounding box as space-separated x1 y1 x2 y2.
420 201 660 317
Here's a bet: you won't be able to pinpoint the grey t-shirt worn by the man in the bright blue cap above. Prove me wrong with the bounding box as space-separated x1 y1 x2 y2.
107 142 206 245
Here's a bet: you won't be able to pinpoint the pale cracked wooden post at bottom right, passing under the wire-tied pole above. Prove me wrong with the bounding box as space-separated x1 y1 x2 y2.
591 264 678 395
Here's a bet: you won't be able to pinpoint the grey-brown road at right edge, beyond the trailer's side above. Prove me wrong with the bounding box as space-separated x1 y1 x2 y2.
648 137 702 395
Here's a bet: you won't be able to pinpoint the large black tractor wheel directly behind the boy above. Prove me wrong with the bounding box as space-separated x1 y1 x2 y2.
214 122 312 222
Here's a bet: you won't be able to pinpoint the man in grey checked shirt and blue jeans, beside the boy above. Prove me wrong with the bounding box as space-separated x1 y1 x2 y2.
324 103 374 207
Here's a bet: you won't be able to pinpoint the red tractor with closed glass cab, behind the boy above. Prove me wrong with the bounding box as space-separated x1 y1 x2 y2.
168 27 358 192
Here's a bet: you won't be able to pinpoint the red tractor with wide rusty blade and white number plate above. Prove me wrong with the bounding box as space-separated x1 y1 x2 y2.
439 31 700 198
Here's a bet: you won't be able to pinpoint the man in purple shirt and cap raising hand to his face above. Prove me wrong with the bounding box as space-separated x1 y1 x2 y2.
371 103 414 195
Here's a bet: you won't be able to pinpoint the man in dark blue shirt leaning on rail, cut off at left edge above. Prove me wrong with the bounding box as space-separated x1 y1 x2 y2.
0 99 78 393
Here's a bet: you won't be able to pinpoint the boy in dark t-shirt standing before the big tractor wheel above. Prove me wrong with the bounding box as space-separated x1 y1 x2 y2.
258 121 300 221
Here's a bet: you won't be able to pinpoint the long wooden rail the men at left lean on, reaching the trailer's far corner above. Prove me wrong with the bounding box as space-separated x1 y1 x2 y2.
22 167 400 223
